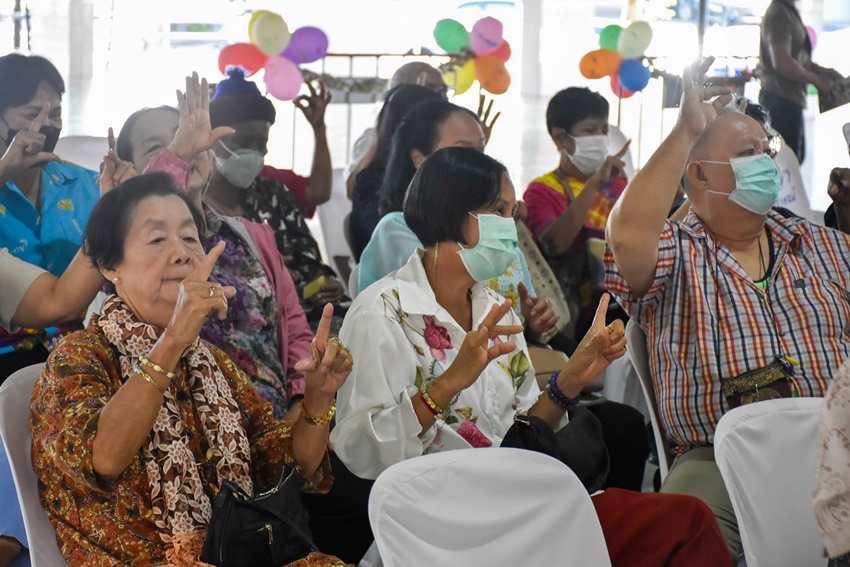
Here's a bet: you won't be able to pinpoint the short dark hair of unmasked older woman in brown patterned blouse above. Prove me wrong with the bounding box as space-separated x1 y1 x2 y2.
83 172 204 270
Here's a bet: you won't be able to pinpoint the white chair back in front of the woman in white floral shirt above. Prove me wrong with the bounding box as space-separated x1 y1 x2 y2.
369 448 611 567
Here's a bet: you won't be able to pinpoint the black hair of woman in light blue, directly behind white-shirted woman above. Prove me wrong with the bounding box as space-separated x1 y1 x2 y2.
378 100 480 216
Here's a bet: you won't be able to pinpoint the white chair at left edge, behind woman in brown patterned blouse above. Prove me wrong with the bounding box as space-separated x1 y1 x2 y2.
0 364 66 567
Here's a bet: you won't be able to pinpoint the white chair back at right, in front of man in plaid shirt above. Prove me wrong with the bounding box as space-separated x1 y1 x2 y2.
714 398 827 567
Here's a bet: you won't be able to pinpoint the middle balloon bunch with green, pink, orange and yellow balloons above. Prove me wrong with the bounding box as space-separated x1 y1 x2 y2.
434 16 511 95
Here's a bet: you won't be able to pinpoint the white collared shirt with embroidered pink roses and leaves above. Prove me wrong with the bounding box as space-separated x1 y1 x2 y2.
331 250 540 478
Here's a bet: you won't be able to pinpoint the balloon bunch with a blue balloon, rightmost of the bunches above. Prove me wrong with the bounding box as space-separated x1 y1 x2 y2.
578 22 652 98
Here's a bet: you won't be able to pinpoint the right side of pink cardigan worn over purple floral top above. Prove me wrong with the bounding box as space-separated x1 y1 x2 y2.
240 218 313 399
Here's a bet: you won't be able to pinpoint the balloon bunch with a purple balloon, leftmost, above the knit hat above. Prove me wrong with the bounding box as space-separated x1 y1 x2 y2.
218 10 328 100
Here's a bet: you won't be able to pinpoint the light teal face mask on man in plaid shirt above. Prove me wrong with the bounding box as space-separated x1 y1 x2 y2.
701 154 781 215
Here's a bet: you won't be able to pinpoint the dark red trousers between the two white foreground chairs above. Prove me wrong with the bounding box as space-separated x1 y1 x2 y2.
591 488 734 567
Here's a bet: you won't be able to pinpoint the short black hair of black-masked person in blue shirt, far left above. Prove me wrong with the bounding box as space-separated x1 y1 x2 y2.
0 53 65 113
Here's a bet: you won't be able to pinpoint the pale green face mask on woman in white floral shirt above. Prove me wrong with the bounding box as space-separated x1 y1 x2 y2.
457 213 519 282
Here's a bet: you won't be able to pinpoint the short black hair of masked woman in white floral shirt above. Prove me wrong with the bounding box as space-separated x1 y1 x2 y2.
404 147 508 248
